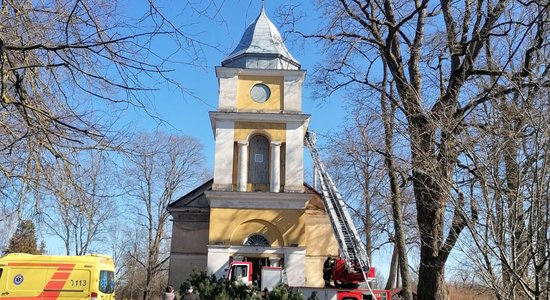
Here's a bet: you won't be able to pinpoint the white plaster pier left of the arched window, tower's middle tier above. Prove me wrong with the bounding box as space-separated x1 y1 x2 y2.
212 121 235 191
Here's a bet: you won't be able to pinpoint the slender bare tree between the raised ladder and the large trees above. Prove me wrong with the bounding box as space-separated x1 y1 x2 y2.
326 109 387 262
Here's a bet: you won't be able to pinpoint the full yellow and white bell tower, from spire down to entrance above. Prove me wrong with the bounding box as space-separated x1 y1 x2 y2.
206 7 311 285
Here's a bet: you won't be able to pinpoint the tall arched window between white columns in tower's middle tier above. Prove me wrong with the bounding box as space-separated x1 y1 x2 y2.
248 135 269 191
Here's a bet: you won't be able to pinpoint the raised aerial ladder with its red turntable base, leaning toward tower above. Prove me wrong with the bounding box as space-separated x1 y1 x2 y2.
304 131 378 293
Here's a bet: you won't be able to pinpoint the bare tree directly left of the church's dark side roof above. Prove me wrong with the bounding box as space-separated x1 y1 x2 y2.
125 132 204 300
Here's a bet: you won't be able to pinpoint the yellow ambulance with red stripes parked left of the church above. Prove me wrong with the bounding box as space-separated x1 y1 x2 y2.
0 253 115 300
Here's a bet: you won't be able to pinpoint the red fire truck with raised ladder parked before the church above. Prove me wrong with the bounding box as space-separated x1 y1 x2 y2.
227 131 391 300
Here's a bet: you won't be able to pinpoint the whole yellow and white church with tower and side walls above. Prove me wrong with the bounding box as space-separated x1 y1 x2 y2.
168 7 338 287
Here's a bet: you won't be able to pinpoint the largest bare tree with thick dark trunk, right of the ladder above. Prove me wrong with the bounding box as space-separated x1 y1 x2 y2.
288 0 548 299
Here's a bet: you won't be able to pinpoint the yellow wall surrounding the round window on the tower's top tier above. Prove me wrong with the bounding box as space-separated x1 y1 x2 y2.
237 75 284 111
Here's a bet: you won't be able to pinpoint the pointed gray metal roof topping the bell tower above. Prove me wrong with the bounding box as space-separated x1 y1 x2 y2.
222 5 300 70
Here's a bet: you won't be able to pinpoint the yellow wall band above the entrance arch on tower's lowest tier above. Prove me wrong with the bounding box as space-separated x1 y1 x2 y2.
209 208 306 247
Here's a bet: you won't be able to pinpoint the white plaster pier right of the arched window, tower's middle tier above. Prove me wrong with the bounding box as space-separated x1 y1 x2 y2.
284 122 304 193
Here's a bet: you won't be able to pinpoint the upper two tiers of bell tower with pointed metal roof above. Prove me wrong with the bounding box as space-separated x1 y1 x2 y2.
210 8 309 193
